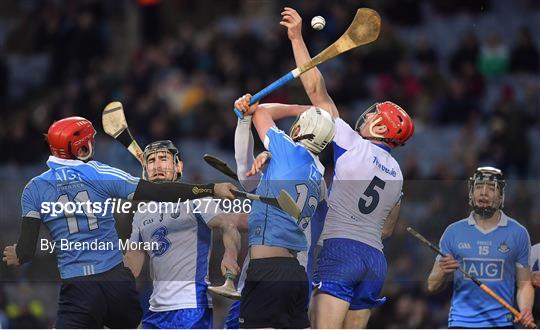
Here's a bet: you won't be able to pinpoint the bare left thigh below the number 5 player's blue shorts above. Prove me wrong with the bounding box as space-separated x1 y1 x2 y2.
309 288 349 329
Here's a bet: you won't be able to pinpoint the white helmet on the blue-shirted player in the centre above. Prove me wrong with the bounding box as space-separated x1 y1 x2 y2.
289 107 336 154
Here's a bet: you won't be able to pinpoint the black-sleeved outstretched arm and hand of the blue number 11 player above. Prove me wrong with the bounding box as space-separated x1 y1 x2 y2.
133 180 236 202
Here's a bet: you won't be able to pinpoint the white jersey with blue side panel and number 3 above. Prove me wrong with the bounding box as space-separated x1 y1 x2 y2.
130 199 222 312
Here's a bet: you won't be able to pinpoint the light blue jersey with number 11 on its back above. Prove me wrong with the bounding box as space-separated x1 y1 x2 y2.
21 156 139 279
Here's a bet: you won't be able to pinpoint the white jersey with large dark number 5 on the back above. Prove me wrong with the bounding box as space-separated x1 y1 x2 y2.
321 118 403 251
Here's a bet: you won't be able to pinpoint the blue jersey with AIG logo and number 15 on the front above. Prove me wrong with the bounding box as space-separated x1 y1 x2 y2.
440 212 531 328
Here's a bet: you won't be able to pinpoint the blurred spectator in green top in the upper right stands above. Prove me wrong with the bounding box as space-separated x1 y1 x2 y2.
478 32 509 78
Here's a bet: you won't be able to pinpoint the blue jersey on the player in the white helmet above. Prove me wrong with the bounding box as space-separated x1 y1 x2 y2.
249 127 324 251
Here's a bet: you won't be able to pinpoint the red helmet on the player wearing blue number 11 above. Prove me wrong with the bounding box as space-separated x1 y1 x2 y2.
47 117 96 160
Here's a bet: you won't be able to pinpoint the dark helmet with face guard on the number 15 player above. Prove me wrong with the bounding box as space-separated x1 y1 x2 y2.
468 167 506 218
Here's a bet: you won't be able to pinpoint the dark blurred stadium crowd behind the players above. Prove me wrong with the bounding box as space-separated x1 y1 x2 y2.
0 0 540 328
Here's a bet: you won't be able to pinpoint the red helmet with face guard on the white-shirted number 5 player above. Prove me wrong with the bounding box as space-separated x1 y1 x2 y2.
355 101 414 148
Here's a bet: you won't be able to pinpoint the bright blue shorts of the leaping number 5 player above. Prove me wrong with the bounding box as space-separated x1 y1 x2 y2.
313 238 387 310
